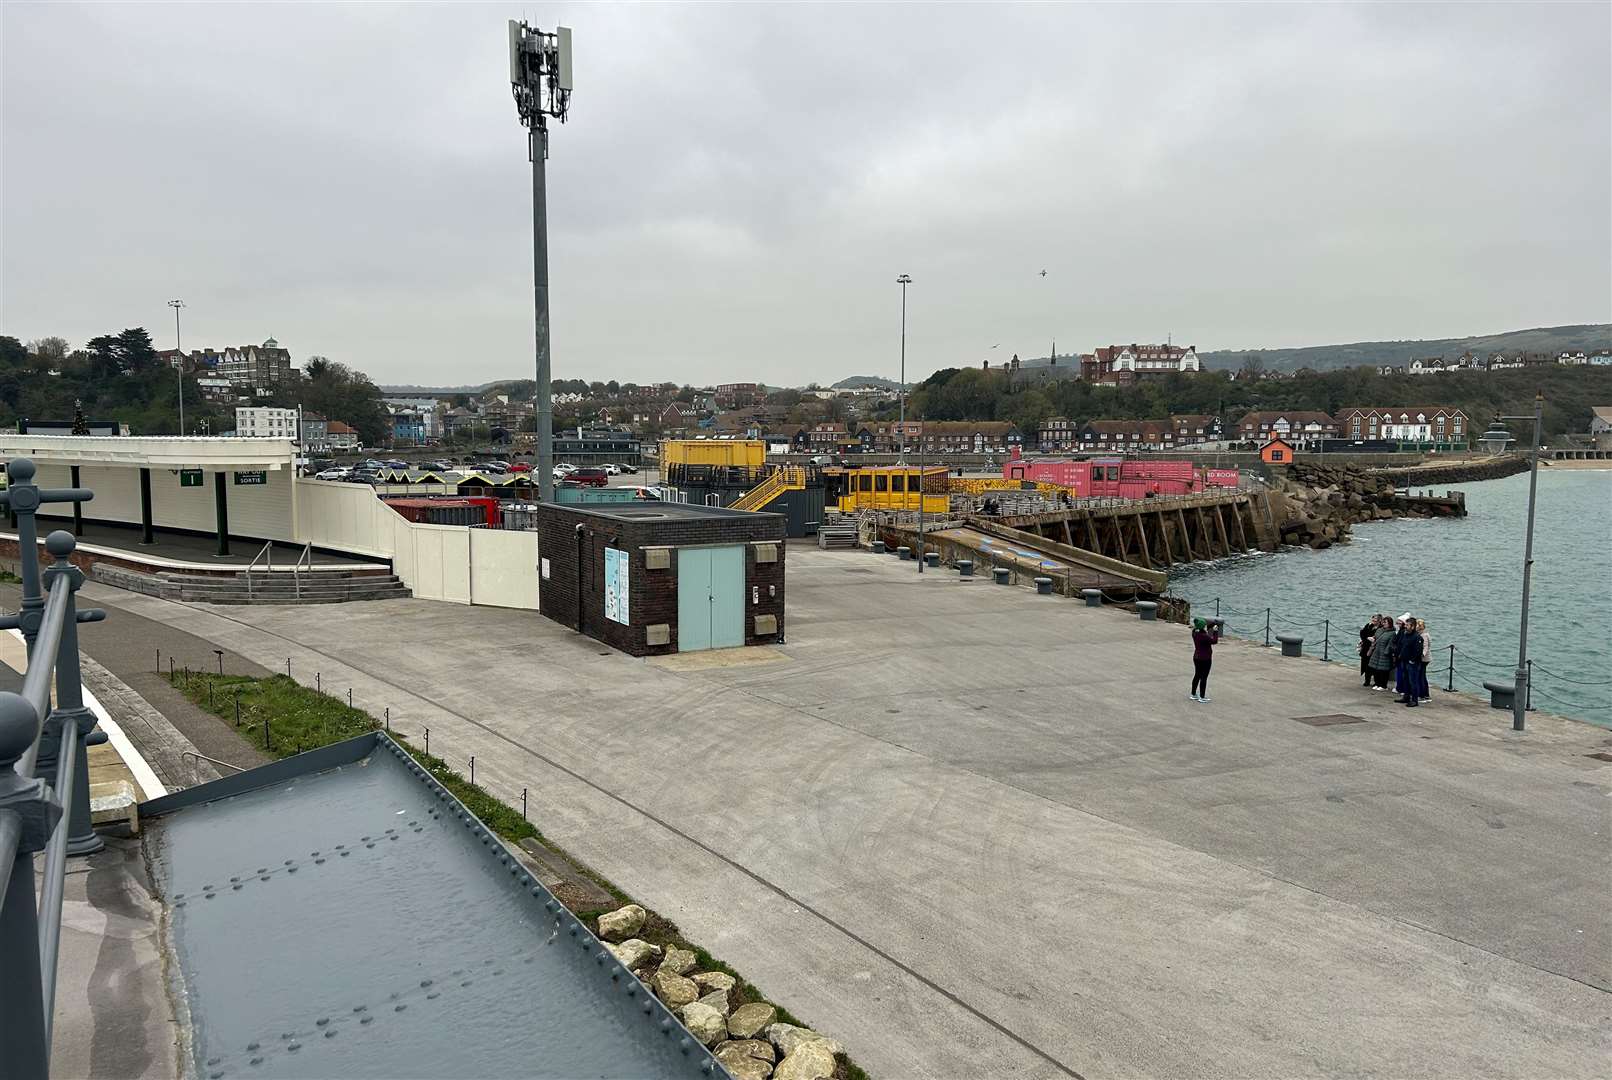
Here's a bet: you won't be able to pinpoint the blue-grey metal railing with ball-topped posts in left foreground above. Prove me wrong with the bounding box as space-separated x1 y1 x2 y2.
0 458 106 1077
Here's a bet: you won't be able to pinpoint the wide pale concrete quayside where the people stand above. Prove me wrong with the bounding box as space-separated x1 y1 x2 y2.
72 548 1612 1077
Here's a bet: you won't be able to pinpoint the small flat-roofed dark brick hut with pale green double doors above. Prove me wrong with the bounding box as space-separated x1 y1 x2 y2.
534 503 787 656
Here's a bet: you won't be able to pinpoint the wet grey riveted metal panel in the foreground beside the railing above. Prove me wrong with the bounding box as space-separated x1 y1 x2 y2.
142 733 725 1078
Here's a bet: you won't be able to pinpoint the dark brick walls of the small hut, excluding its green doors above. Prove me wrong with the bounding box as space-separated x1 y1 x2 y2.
537 506 785 656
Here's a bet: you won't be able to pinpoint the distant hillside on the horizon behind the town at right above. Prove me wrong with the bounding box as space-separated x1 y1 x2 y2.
1198 322 1612 371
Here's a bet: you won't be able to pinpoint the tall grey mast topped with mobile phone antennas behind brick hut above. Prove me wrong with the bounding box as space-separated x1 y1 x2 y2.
509 19 571 503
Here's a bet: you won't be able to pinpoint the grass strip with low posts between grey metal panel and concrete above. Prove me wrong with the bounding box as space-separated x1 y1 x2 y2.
169 671 867 1080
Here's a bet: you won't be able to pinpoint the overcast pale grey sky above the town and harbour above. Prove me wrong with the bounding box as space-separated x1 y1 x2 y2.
0 0 1612 385
